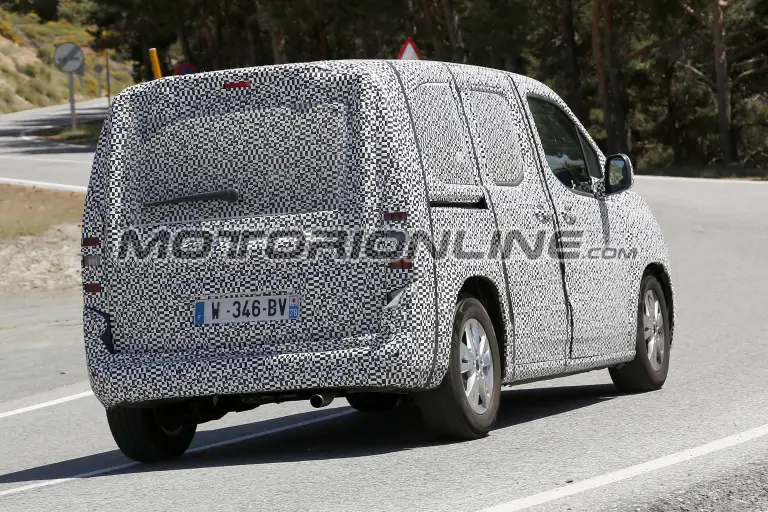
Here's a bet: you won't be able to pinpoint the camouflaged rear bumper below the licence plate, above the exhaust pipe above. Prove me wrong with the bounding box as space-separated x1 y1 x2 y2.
86 333 432 407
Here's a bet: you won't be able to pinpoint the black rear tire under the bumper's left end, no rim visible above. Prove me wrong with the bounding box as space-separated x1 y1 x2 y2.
107 406 197 462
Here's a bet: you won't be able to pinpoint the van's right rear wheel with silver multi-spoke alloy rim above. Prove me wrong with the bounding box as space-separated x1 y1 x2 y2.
413 295 502 440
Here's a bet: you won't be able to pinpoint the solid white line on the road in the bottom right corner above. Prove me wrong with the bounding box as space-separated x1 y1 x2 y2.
479 424 768 512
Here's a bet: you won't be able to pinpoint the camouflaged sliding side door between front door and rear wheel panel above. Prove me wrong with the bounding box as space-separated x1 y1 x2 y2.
451 65 570 382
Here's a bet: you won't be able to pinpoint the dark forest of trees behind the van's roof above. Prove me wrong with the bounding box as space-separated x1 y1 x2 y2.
0 0 768 167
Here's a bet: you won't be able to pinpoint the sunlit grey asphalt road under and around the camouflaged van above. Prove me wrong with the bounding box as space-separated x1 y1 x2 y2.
0 102 768 512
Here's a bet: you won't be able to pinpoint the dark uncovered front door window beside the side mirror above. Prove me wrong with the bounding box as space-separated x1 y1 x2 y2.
528 98 592 189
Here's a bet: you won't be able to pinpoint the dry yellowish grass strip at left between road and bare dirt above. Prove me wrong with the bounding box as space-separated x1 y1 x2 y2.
0 185 85 239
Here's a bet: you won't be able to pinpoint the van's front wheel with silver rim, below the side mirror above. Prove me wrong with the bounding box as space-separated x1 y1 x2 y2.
609 275 670 393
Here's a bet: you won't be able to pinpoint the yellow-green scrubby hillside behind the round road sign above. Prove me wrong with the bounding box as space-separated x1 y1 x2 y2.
0 9 133 113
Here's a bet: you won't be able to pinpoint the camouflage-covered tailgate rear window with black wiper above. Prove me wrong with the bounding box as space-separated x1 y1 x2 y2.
134 103 350 223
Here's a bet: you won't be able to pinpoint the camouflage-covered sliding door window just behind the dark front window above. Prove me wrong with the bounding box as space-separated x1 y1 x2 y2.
464 91 524 185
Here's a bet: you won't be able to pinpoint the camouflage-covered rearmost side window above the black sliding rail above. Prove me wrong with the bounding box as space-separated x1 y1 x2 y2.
411 83 477 185
